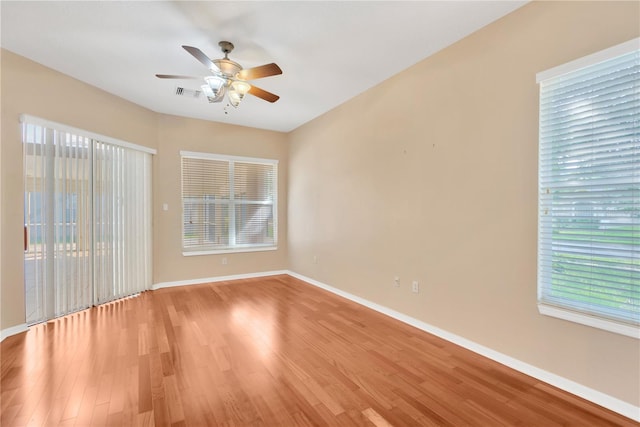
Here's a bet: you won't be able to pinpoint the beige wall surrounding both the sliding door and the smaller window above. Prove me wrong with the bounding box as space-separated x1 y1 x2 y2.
0 50 287 330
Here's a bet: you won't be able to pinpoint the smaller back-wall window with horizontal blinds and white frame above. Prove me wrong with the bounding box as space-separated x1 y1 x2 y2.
180 151 278 255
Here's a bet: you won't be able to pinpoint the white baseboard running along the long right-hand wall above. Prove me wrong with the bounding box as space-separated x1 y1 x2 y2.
287 271 640 422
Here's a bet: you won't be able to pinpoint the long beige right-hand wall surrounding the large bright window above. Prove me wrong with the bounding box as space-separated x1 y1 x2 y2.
289 2 640 405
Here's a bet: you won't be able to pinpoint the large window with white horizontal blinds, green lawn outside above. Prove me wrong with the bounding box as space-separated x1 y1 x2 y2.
537 39 640 338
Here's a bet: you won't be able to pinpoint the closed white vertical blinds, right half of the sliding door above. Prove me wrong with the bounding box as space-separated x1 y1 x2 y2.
93 141 152 304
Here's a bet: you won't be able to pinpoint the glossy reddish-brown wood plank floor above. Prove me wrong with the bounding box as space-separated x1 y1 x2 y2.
0 276 638 427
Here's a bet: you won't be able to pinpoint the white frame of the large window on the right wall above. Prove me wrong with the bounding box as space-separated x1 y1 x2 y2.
536 38 640 339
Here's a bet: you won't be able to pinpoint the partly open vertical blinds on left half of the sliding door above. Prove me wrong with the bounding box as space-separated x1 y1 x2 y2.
23 124 93 324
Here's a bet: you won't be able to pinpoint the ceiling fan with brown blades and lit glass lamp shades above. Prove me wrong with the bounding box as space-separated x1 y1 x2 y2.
156 41 282 107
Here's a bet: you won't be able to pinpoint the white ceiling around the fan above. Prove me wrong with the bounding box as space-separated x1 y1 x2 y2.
0 0 526 132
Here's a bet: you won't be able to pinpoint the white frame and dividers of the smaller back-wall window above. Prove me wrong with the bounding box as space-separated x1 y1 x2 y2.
180 151 279 256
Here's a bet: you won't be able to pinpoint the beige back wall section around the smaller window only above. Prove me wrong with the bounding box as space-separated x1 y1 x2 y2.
153 115 288 283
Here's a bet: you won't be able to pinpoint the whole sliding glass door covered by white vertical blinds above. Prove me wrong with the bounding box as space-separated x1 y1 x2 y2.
23 118 151 324
